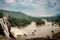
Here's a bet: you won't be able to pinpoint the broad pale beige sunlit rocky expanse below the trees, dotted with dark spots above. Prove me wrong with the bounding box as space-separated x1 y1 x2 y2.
11 19 60 38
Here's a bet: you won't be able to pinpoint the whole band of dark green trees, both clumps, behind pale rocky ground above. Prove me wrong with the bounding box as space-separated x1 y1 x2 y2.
8 16 45 27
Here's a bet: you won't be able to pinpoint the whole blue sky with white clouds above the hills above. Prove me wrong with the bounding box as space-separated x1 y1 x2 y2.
0 0 60 17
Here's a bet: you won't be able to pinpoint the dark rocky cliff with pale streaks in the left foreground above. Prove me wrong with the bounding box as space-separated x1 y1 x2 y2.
0 17 14 40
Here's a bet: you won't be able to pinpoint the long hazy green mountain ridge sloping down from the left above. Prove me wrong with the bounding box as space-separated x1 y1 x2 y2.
0 10 29 18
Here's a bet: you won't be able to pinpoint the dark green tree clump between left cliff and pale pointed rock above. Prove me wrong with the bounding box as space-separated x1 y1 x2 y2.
8 16 31 27
